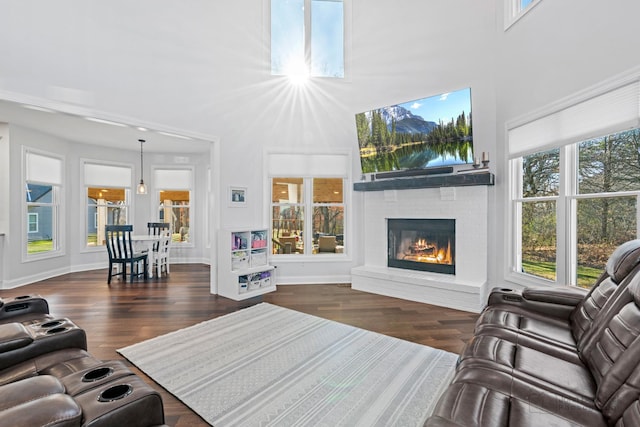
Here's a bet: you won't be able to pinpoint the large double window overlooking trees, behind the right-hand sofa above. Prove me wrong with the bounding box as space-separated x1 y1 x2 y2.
508 82 640 287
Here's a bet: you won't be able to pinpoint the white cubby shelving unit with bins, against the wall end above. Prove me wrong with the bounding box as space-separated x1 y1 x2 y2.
218 228 276 301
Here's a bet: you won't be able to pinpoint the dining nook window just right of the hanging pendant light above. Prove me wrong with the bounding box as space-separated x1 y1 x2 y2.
154 169 194 245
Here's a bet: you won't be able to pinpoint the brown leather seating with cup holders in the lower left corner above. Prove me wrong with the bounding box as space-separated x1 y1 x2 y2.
0 295 164 427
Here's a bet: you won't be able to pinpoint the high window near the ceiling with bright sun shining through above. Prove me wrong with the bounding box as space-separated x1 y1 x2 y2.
270 0 345 78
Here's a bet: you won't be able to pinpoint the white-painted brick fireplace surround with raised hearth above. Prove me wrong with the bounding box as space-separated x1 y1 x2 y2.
351 174 491 312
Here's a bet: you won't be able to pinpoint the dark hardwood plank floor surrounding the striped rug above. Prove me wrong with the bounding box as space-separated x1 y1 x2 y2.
0 264 478 426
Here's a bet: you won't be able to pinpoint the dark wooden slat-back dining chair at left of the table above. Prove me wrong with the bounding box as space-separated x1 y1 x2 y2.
105 225 148 284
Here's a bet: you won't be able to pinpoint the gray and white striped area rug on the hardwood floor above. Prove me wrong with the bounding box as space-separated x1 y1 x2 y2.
118 303 457 427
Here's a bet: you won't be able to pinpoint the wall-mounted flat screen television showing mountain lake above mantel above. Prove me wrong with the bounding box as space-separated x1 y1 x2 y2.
356 88 473 173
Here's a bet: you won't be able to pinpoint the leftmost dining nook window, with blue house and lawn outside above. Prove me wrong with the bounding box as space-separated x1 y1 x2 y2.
23 149 64 259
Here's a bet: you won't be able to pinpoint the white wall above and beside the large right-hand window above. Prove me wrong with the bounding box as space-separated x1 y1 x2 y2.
490 0 640 288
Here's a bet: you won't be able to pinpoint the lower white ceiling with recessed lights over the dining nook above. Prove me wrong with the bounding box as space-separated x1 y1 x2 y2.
0 99 211 154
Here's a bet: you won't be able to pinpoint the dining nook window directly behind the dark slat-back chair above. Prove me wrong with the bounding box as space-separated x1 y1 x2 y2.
83 161 132 247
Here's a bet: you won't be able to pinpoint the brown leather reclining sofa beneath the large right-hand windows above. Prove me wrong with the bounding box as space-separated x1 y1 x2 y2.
425 240 640 427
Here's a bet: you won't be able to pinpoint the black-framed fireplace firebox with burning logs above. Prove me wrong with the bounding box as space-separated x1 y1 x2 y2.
387 218 456 274
